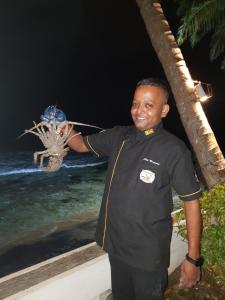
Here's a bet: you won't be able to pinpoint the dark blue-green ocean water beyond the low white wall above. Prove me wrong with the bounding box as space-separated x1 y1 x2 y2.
0 152 178 276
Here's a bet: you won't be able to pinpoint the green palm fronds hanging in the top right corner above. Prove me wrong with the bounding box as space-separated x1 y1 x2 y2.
173 0 225 70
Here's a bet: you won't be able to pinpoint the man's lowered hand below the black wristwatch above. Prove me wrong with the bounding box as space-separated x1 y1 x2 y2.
178 259 201 288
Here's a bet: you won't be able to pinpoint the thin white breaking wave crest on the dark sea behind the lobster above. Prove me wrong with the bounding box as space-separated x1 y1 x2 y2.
0 161 106 176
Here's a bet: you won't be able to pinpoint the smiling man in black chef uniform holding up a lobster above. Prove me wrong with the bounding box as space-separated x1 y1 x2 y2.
69 78 201 300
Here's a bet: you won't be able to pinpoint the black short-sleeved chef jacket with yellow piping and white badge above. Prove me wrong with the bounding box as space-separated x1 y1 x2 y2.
84 123 200 270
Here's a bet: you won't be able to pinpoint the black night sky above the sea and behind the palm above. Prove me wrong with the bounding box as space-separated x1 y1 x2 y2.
0 0 225 151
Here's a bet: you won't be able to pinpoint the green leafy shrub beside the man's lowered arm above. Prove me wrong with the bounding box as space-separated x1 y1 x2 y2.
176 184 225 289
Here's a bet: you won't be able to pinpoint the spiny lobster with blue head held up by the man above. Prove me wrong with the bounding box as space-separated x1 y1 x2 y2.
23 105 102 172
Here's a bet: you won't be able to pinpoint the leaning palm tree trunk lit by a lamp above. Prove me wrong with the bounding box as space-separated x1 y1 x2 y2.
136 0 225 188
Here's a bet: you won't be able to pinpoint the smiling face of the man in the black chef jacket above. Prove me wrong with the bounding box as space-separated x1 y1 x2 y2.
131 85 169 131
